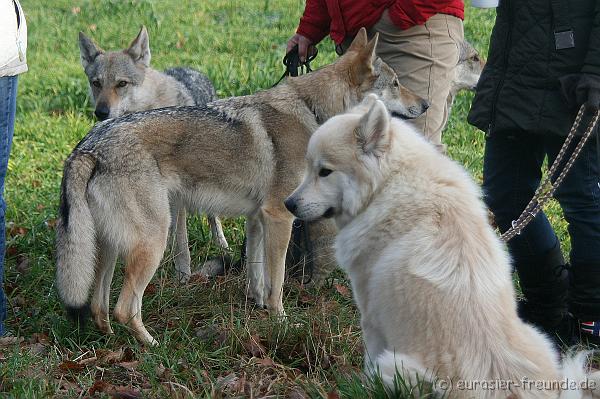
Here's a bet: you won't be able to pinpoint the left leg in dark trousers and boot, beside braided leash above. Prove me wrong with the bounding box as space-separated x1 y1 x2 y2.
483 132 568 334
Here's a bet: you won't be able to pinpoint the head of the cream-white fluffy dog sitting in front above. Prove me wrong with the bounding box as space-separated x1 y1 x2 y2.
285 94 398 227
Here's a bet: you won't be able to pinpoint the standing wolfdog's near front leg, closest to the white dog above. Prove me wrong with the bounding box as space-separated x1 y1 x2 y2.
261 205 294 316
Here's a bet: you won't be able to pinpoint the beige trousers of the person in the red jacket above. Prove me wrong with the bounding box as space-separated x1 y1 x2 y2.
369 10 464 144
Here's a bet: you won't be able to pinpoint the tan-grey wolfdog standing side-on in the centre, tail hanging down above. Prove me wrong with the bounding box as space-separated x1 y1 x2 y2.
56 29 428 344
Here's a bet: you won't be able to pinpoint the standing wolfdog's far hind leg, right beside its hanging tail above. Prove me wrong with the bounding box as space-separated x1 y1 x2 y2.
90 240 117 334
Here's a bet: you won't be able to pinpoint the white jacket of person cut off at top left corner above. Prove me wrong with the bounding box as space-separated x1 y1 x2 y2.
0 0 27 77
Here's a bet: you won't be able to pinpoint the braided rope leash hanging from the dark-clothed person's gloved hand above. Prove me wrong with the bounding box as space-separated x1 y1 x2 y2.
500 105 600 242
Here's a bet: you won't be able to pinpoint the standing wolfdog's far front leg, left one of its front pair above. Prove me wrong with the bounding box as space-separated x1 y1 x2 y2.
246 214 265 307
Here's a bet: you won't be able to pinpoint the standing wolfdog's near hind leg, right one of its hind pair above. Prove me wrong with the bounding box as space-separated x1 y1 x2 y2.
115 230 168 345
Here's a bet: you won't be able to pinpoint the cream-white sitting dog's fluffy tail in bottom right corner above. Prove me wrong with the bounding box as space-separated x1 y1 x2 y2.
560 351 600 399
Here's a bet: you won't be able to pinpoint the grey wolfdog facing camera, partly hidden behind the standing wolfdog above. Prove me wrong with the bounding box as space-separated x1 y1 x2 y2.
79 26 228 282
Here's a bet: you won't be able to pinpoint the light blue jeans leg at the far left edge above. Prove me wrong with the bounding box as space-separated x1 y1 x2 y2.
0 76 17 336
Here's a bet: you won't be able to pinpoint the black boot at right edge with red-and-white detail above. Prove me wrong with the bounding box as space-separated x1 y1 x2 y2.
569 261 600 346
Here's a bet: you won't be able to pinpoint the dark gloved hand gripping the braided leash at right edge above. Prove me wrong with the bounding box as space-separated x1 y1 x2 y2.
560 73 600 111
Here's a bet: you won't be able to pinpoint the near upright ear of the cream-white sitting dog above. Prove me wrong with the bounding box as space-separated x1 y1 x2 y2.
354 96 390 157
